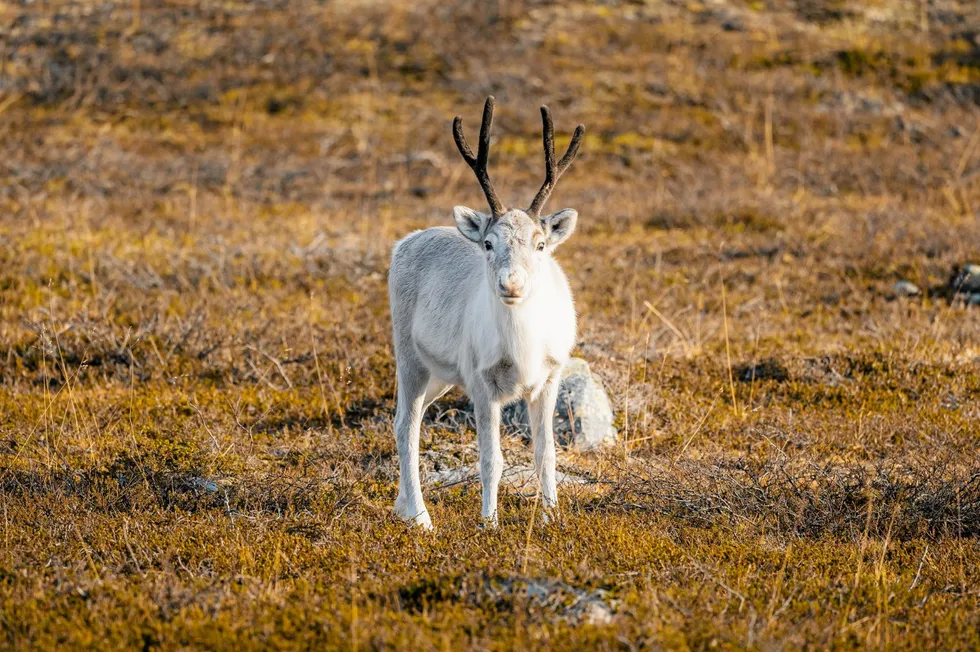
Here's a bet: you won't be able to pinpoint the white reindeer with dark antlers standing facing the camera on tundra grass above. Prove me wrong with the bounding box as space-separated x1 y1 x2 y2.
388 97 585 529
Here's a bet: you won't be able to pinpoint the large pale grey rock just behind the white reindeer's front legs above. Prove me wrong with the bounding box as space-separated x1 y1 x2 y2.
502 358 617 451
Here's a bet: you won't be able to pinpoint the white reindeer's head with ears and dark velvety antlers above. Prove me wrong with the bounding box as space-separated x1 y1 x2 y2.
453 96 585 306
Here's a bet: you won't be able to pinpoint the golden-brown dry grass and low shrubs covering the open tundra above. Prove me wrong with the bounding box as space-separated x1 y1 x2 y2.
0 0 980 649
